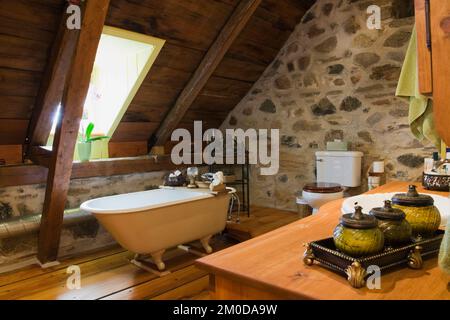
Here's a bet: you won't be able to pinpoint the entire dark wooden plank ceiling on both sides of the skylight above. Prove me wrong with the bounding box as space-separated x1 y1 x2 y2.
0 0 314 158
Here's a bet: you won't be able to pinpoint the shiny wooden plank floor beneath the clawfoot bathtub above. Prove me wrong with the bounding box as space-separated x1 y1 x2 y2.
0 208 296 300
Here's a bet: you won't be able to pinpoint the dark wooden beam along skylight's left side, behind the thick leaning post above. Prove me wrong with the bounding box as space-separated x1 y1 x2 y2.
24 3 80 158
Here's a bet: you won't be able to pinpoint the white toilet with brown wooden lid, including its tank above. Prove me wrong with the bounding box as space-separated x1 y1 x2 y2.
297 151 363 213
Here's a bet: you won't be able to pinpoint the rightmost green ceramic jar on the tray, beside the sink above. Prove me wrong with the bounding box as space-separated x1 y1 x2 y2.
392 185 441 236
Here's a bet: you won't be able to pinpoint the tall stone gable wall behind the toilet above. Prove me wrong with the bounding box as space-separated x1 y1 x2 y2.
223 0 433 209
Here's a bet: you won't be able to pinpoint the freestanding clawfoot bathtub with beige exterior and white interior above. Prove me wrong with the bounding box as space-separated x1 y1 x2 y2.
81 189 230 270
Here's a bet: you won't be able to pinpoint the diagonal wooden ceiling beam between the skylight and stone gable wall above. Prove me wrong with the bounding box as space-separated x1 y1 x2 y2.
149 0 261 148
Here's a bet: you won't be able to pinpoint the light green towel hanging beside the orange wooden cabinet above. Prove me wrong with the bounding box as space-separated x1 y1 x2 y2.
396 27 441 150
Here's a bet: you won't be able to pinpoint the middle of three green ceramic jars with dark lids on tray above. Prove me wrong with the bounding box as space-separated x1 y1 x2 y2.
369 200 412 246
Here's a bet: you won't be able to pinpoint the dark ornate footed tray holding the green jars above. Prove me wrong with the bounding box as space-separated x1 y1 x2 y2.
303 230 445 288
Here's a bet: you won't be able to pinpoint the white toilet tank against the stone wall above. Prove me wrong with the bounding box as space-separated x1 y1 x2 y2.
316 151 363 188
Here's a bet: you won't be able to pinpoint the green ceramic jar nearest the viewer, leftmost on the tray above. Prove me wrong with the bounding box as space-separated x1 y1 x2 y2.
333 206 384 257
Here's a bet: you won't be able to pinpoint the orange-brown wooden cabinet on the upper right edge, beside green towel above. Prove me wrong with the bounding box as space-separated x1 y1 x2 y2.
415 0 450 145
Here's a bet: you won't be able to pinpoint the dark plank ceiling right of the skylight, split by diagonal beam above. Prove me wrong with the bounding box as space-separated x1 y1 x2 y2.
107 0 312 145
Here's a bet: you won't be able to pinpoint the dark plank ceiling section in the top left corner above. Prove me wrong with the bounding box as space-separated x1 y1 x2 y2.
0 0 64 145
